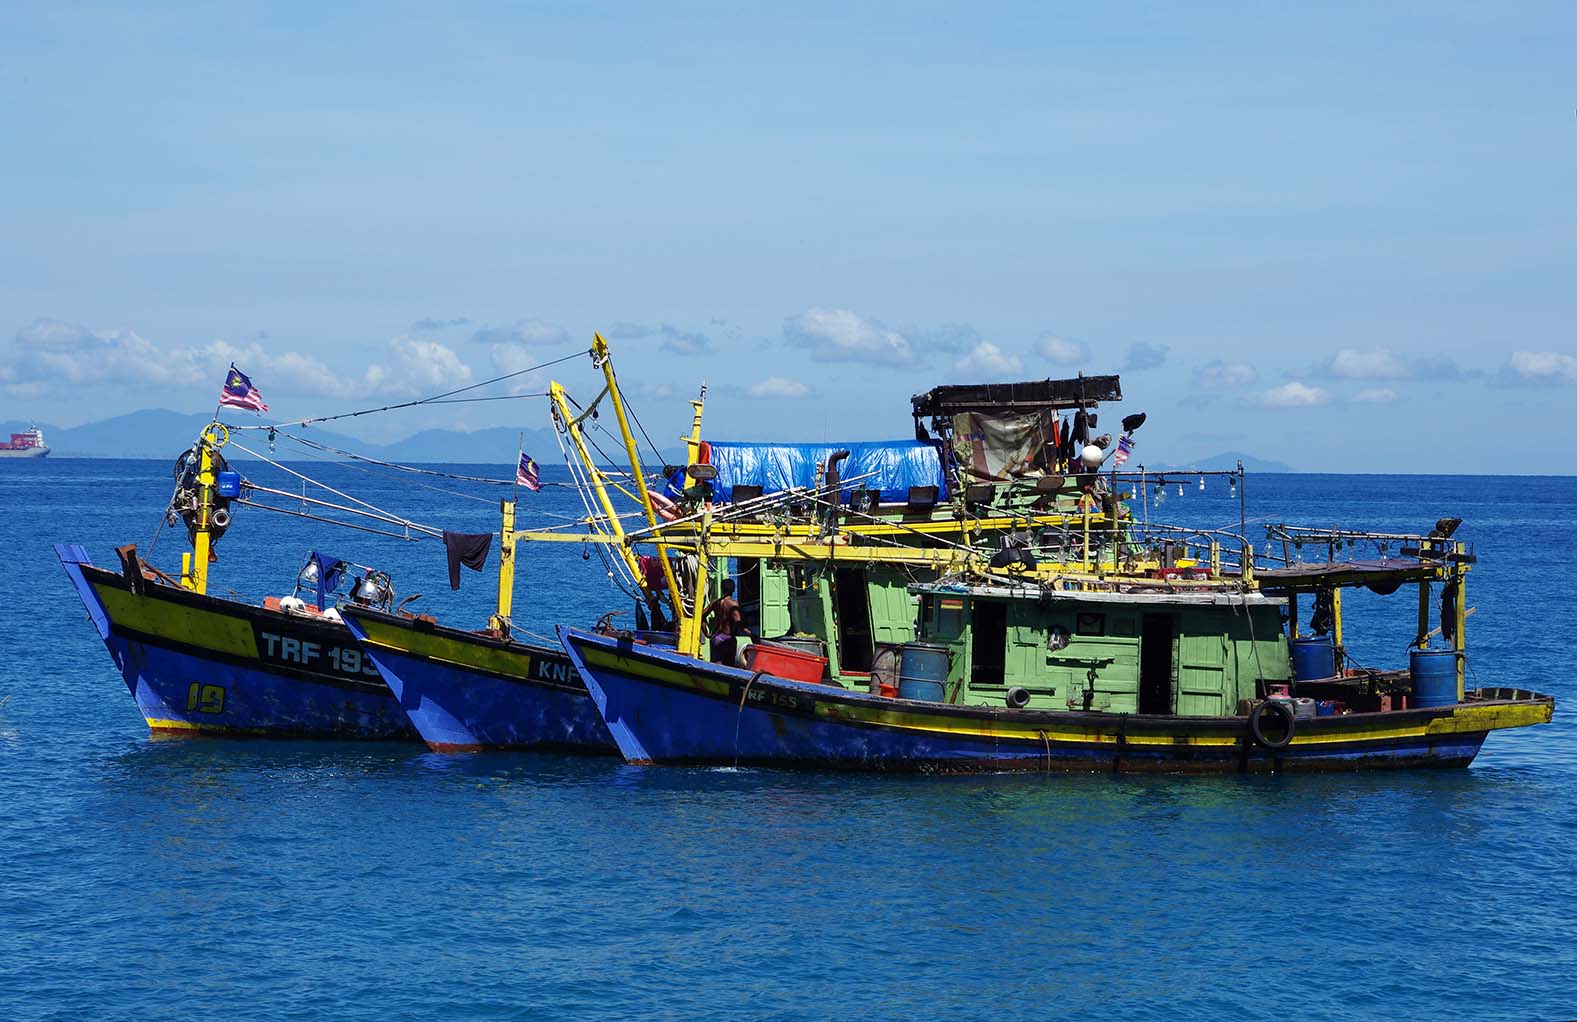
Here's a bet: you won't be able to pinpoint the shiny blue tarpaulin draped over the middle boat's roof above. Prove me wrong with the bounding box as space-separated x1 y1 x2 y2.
670 440 948 503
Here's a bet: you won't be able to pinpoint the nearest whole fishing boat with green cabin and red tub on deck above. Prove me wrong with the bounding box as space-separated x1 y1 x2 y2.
560 385 1553 773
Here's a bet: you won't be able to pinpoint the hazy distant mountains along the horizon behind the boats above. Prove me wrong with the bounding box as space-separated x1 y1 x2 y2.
0 408 1292 472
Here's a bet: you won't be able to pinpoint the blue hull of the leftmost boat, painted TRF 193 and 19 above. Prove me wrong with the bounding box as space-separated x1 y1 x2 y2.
55 544 416 741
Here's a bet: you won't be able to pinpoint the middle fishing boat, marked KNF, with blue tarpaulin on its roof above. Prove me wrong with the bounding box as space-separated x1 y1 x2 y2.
344 336 1141 754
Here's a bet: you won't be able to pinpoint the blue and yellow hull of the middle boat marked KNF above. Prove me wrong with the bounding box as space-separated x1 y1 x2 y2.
345 612 617 755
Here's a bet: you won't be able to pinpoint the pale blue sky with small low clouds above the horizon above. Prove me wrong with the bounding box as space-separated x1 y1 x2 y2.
0 3 1577 473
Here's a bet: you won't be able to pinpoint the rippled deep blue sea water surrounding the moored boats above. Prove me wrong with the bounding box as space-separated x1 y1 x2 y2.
0 459 1577 1022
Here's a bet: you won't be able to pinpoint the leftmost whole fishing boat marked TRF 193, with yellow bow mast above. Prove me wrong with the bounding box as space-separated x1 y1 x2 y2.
55 423 589 741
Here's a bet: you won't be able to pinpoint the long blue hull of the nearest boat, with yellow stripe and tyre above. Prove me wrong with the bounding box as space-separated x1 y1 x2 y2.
561 629 1487 773
